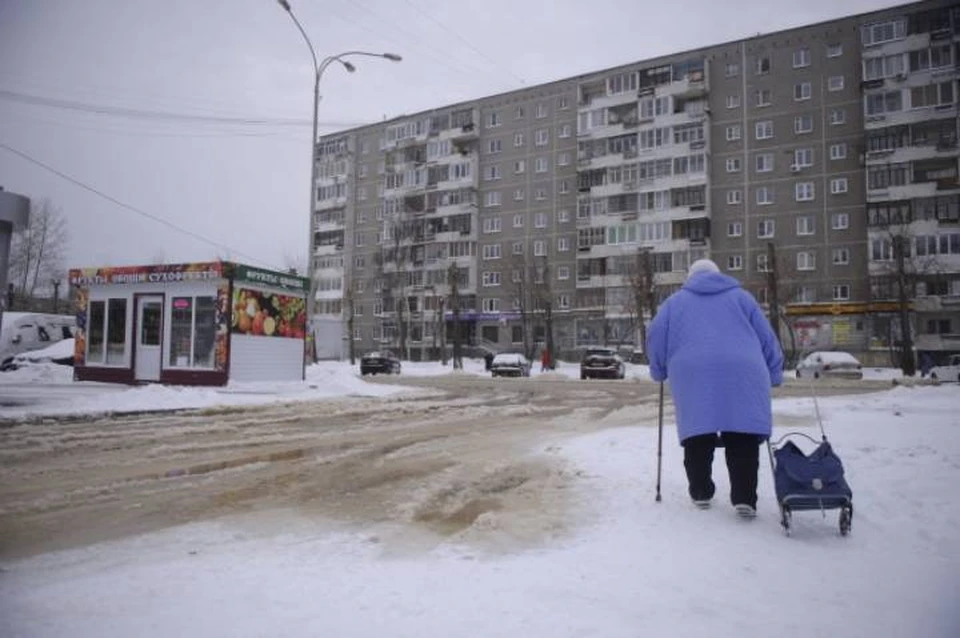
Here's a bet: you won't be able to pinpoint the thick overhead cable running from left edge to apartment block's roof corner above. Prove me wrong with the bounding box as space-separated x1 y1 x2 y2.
0 89 369 128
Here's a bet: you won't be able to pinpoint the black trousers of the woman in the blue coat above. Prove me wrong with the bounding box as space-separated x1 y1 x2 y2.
683 432 763 508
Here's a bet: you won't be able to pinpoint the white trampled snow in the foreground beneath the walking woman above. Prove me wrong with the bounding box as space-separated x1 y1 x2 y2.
0 382 960 638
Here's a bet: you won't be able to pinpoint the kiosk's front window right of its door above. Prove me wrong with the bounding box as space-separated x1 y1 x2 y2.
169 296 217 368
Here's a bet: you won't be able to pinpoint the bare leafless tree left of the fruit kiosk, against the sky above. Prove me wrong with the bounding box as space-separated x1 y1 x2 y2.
10 198 69 299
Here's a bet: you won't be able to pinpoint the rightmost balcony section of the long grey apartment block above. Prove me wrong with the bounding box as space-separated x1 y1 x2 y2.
861 3 960 362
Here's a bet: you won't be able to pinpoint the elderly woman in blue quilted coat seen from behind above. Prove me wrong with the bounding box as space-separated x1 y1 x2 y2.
647 259 783 518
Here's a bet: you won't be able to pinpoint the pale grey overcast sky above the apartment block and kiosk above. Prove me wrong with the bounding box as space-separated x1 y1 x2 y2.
0 0 899 268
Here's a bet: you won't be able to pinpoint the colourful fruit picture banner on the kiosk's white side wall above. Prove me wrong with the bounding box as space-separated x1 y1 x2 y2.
231 288 307 339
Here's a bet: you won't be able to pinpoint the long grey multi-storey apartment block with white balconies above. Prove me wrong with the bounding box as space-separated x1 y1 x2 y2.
313 1 960 363
